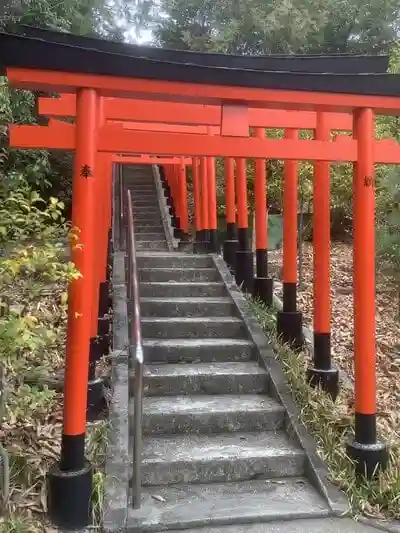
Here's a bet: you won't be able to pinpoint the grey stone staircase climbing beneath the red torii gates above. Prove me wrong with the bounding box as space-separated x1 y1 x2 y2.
118 167 339 533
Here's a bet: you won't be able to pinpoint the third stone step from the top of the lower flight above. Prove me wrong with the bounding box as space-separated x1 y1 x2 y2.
139 280 228 298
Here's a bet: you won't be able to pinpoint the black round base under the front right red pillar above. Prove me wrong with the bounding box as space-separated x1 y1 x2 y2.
346 440 389 479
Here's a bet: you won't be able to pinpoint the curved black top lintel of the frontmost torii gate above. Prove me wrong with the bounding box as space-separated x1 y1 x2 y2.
0 33 400 97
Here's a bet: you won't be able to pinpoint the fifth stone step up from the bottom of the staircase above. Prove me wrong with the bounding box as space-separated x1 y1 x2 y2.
143 338 254 364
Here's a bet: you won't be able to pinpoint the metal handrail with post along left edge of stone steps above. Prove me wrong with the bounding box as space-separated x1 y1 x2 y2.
126 185 143 509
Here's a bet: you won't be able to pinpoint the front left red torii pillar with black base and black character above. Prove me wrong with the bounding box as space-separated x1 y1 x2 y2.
47 89 98 527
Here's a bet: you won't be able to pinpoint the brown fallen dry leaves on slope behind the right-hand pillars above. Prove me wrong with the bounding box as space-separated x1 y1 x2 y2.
270 243 400 445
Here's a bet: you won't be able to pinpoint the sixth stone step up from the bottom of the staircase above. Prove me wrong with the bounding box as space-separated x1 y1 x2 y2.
141 317 247 339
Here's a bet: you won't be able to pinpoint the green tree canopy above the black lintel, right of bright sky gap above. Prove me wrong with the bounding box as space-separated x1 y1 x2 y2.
142 0 399 55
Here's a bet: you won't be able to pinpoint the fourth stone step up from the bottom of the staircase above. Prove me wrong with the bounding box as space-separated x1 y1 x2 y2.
144 361 269 396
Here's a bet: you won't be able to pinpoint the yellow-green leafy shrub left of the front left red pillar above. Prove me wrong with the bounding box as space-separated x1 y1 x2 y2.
0 179 79 416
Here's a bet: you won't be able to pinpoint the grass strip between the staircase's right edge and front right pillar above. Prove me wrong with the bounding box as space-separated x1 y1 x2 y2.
248 298 400 519
